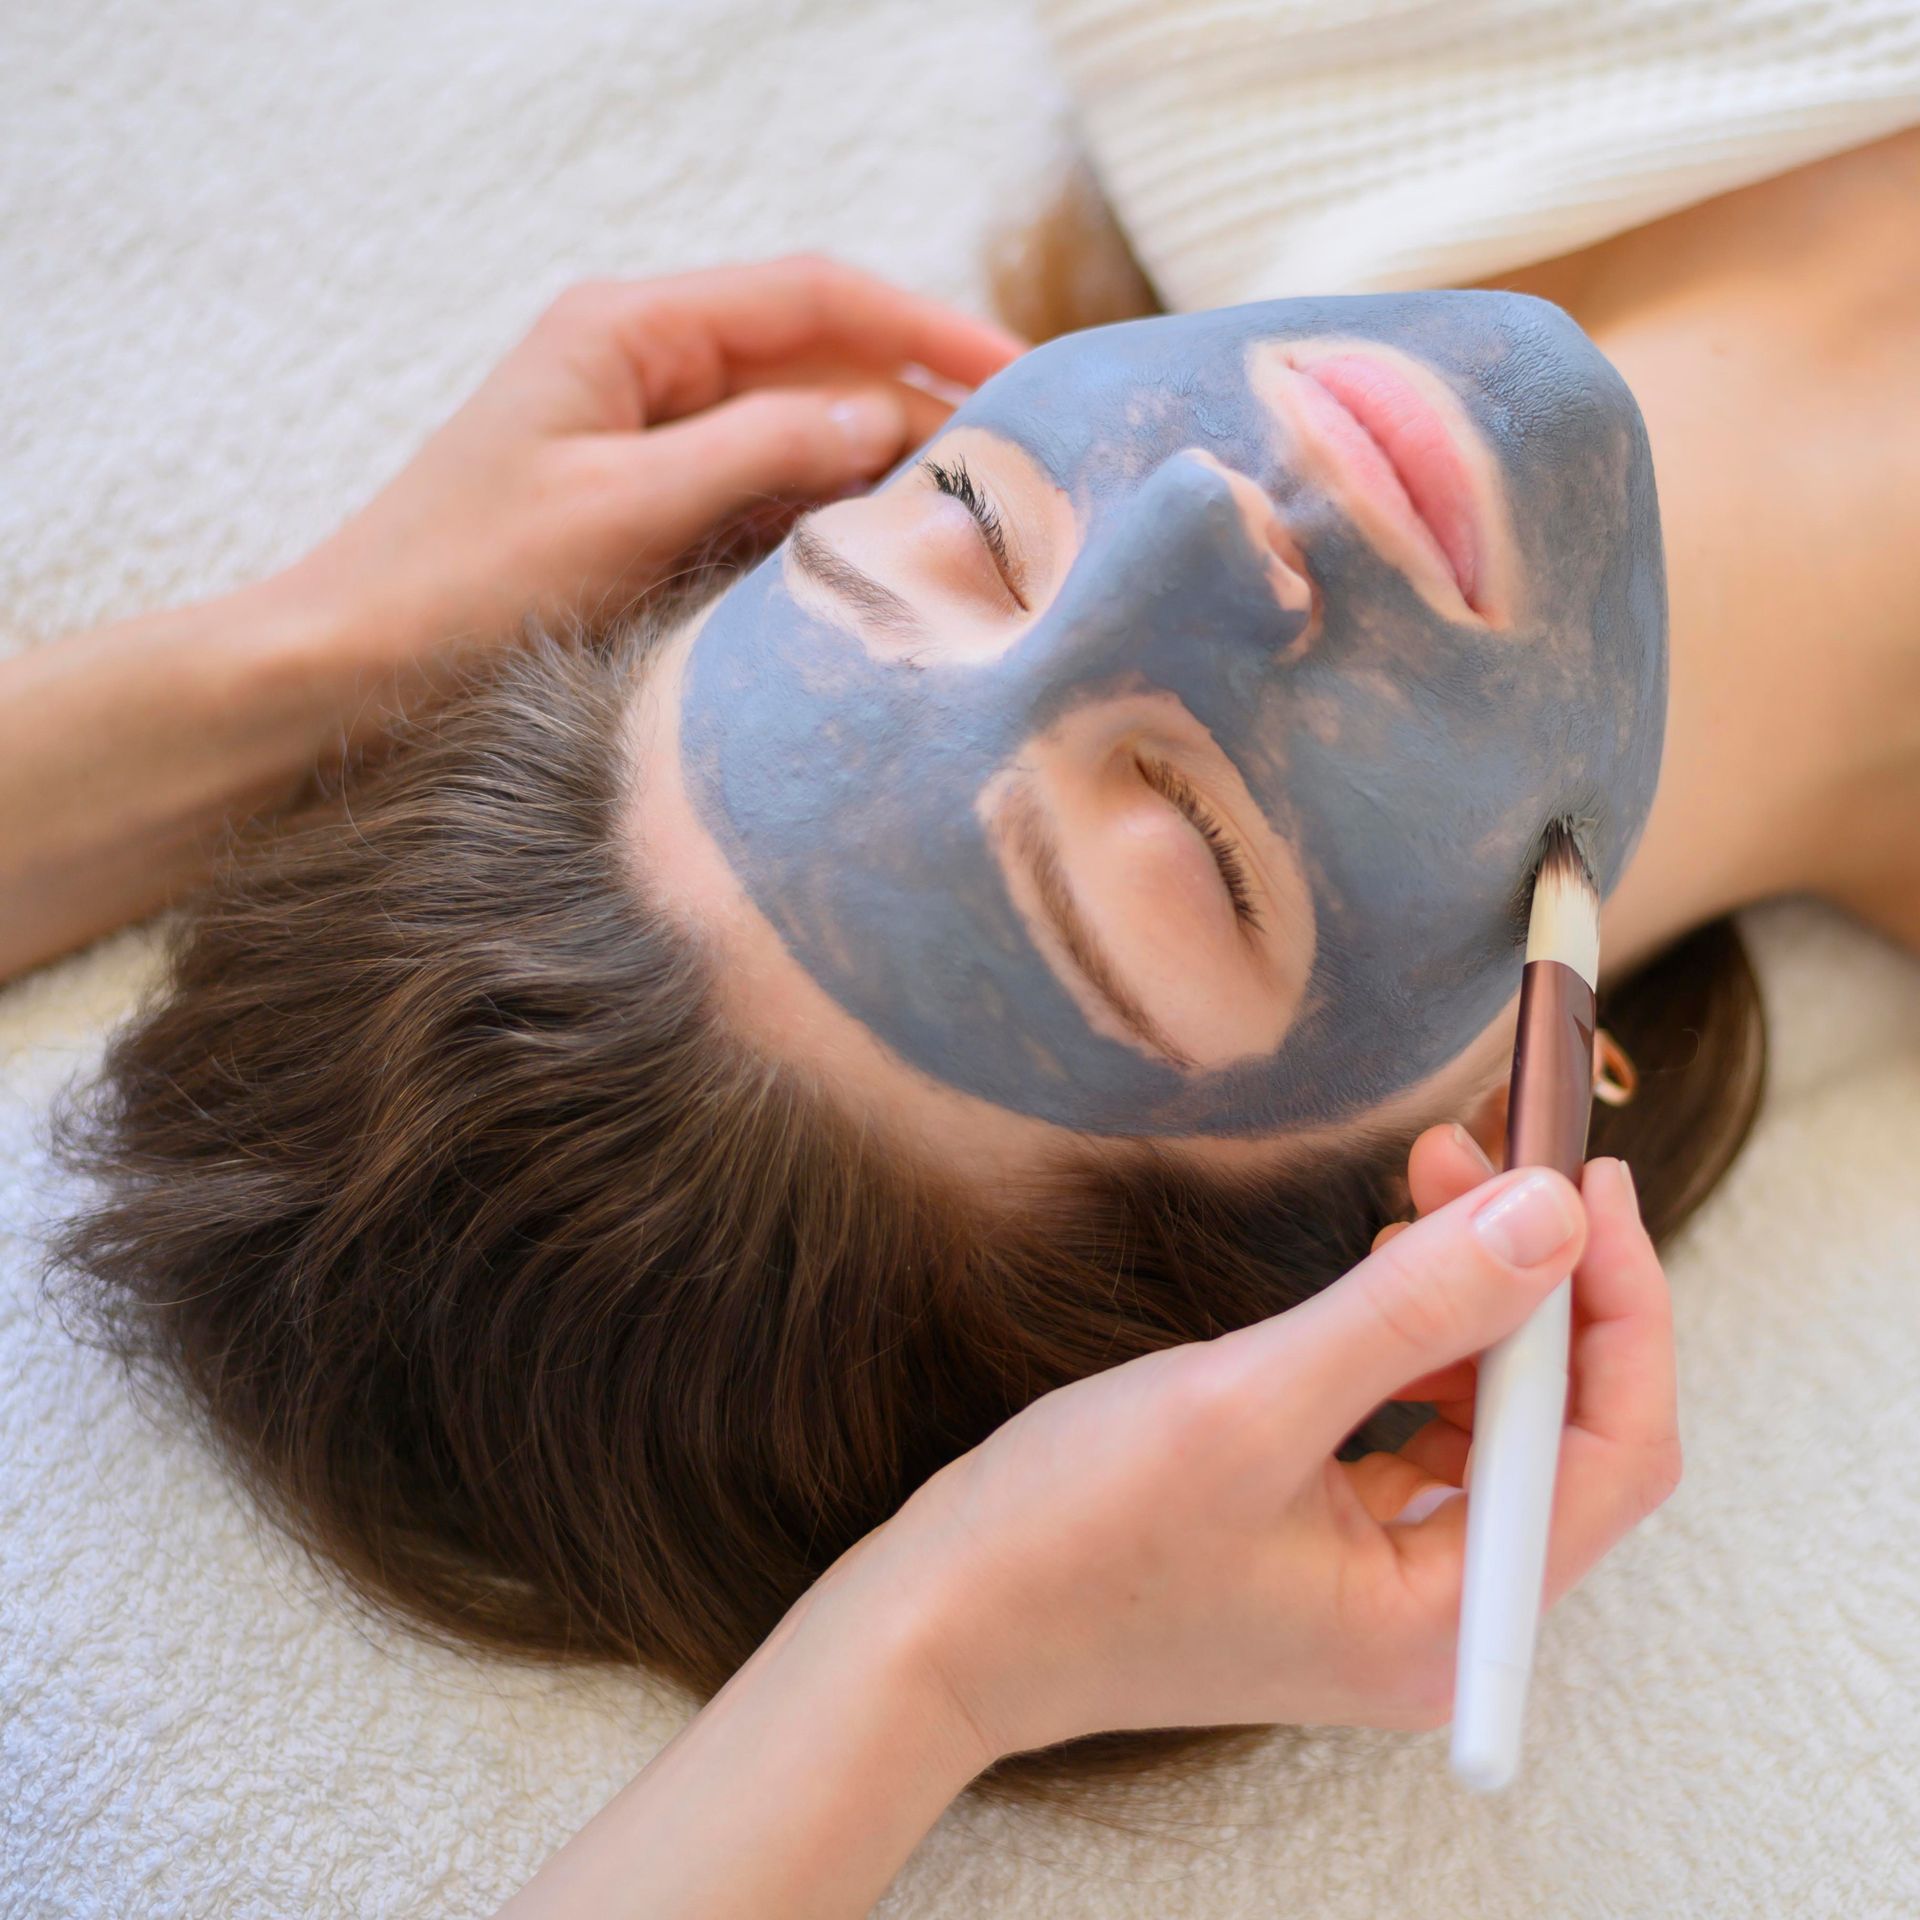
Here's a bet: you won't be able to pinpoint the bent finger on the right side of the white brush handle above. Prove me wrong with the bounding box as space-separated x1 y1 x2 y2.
1548 1160 1680 1599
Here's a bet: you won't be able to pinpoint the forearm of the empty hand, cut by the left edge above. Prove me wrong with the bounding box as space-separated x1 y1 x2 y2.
0 576 378 979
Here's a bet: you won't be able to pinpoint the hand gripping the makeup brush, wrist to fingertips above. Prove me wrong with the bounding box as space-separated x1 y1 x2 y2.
864 1129 1680 1764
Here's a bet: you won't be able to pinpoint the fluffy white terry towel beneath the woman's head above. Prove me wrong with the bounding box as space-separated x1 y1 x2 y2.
0 0 1920 1920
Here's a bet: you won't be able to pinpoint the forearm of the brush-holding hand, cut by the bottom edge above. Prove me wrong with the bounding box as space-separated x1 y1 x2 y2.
501 1543 985 1920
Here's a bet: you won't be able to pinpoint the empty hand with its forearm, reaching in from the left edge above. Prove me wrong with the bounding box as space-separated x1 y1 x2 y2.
0 259 1020 979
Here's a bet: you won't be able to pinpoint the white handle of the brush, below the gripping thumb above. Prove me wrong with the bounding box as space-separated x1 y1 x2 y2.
1452 1281 1572 1793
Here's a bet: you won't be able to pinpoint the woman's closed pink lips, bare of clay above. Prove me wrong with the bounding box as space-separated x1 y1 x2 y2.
1298 353 1486 612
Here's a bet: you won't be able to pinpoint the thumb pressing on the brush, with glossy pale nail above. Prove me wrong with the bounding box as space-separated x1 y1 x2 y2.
1251 1167 1586 1452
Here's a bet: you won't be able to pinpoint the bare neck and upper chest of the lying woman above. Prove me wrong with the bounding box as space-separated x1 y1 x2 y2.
1501 134 1920 972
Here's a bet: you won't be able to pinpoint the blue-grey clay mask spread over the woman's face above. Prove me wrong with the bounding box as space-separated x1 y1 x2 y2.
680 292 1667 1137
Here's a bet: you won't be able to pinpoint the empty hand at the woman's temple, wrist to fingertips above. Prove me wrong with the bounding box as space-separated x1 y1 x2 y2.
282 257 1021 687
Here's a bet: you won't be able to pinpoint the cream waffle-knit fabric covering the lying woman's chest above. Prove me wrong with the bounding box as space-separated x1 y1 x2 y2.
1041 0 1920 309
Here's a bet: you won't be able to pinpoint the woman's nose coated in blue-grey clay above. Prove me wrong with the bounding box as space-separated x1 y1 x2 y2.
1020 449 1313 707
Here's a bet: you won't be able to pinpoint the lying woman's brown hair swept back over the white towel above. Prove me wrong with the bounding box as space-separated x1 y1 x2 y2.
45 206 1763 1811
